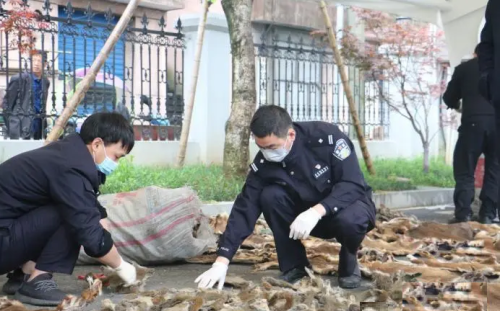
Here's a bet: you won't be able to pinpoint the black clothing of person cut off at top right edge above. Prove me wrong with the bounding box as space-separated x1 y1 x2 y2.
477 0 500 105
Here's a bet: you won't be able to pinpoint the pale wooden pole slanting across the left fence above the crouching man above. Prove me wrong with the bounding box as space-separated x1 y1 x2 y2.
45 0 141 145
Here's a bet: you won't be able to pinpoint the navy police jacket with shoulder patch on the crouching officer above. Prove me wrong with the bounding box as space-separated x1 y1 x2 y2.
217 122 374 260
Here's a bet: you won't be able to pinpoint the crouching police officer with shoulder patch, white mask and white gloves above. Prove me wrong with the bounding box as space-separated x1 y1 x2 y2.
195 106 376 289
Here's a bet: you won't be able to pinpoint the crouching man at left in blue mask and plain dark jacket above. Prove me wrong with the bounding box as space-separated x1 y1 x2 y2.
0 113 136 306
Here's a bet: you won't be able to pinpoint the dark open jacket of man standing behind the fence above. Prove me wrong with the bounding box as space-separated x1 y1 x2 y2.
2 72 50 139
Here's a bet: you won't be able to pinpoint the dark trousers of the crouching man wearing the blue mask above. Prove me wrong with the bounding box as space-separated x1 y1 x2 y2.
0 206 80 275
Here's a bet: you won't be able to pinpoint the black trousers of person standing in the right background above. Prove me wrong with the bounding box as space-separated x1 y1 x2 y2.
453 118 500 219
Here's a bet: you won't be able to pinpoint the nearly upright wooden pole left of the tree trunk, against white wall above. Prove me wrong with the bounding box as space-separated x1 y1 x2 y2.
177 0 212 167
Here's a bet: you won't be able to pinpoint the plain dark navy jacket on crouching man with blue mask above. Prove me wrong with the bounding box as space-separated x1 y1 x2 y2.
0 134 113 257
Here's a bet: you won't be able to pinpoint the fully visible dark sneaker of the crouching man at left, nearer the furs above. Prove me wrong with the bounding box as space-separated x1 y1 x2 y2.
14 273 66 307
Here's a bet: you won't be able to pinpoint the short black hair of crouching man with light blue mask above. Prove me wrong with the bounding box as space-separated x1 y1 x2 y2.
80 112 135 153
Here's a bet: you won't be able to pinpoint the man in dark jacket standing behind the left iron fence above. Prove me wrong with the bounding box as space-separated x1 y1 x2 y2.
2 51 50 139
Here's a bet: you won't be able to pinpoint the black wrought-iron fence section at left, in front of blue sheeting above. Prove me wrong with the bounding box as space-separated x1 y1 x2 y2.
0 0 184 140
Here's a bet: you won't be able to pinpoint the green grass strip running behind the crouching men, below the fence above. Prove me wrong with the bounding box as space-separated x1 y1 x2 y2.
101 159 454 202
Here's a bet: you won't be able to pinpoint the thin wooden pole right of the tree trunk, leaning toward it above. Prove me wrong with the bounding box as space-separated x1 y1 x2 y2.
320 0 375 175
